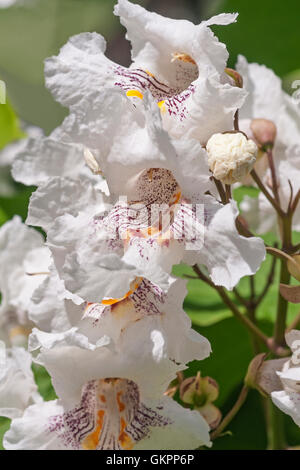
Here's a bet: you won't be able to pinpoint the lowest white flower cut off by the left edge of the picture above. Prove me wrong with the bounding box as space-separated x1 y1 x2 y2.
0 341 42 418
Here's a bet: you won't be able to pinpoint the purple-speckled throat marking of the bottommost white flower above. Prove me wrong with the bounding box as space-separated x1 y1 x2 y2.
48 379 172 450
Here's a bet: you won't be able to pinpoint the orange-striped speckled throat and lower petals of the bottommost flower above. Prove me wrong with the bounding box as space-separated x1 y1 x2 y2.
3 377 210 450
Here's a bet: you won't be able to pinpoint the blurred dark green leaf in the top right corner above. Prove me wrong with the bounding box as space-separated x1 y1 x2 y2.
214 0 300 76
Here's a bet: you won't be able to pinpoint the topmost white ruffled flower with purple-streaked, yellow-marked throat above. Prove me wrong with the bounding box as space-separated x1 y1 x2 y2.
45 0 246 143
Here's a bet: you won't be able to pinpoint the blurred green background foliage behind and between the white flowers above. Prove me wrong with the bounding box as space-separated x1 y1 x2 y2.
0 0 300 449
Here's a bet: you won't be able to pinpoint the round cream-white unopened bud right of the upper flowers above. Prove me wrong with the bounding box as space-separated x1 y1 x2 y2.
206 132 257 184
